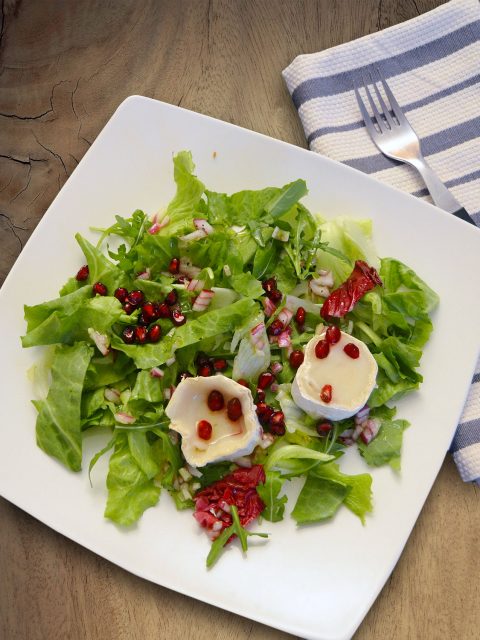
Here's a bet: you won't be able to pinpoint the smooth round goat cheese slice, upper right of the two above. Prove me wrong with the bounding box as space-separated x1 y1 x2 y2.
292 331 378 420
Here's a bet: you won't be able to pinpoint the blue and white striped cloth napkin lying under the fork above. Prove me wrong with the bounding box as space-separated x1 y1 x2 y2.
283 0 480 484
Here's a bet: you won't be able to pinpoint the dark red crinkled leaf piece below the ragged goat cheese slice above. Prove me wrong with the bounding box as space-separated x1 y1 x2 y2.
193 464 265 540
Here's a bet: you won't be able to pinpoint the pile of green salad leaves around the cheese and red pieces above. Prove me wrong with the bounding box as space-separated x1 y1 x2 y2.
22 151 438 565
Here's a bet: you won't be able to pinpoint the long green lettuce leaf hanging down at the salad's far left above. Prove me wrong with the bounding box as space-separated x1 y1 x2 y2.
34 342 93 471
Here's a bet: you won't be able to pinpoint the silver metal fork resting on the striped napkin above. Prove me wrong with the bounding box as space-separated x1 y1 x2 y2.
354 68 476 226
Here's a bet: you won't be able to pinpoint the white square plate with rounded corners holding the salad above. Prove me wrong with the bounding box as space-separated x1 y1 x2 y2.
0 97 480 640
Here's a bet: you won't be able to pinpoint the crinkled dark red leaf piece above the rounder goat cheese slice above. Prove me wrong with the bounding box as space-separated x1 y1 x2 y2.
320 260 383 318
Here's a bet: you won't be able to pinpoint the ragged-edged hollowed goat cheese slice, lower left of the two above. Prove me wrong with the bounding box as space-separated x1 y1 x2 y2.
165 375 262 467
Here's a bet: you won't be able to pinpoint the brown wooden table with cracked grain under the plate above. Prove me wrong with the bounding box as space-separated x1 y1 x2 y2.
0 0 480 640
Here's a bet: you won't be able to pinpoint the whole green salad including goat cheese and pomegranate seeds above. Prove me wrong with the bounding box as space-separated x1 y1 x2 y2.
22 151 438 566
